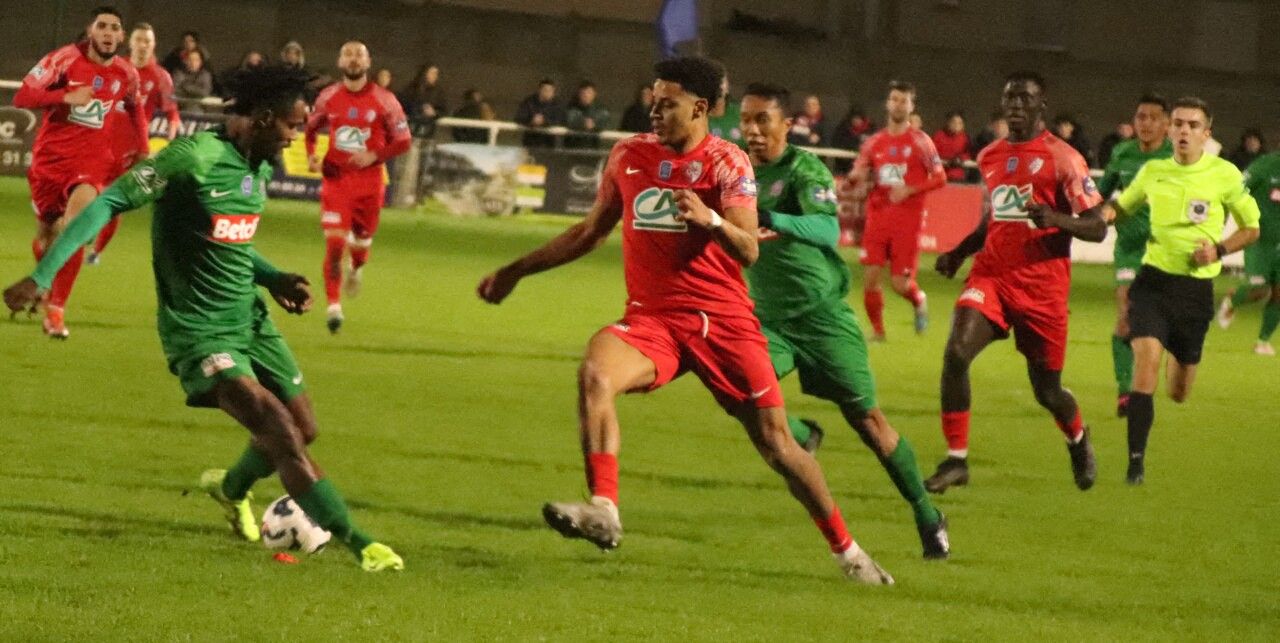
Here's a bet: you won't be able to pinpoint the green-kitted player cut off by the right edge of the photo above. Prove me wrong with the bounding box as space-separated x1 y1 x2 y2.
1217 152 1280 356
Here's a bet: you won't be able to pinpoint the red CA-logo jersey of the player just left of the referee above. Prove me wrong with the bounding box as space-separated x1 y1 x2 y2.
973 132 1102 288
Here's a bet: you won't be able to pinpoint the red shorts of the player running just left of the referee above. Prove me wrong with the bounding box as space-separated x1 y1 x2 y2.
956 274 1068 370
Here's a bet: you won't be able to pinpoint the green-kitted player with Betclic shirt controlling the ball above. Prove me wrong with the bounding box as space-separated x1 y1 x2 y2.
4 68 404 571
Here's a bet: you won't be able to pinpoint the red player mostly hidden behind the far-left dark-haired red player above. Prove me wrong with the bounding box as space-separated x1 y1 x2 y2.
84 22 182 265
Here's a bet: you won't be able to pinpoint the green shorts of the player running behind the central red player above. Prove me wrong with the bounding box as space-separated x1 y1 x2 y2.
762 301 876 411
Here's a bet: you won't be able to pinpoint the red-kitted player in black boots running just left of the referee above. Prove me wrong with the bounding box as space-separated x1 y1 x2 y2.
924 72 1107 493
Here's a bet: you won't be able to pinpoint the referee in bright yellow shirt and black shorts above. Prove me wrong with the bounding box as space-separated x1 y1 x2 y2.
1105 97 1260 484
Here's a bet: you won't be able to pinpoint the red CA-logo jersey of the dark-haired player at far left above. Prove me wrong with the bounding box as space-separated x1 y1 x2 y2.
13 44 147 174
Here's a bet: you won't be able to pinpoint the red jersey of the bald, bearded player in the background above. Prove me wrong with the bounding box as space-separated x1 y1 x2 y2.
306 82 412 182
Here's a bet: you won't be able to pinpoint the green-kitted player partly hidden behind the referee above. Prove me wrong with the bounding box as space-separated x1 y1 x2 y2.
1098 94 1174 418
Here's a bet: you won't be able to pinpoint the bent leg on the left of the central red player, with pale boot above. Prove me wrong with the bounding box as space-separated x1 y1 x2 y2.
543 324 660 549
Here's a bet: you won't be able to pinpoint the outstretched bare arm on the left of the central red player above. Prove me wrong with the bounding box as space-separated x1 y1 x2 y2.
476 187 624 304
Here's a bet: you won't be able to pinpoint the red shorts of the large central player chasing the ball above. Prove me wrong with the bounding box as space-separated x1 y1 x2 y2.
605 307 782 412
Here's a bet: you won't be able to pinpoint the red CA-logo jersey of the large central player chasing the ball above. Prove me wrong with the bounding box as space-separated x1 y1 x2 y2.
598 133 756 316
